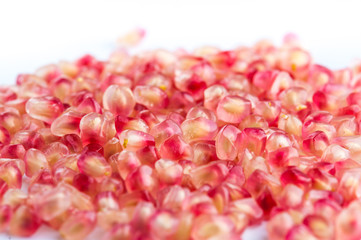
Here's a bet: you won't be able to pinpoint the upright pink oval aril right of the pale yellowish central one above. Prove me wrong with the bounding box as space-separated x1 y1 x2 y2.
216 125 241 160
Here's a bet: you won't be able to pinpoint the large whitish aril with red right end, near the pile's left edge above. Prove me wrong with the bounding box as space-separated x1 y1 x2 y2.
25 96 64 124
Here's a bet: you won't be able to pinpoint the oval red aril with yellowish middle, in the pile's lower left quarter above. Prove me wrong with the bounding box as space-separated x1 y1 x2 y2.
77 152 112 179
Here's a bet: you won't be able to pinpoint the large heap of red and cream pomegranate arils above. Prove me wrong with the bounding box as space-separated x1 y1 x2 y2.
0 33 361 240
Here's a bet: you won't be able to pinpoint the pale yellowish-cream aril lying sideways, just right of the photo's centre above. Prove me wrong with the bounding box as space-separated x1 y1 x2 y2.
181 117 218 142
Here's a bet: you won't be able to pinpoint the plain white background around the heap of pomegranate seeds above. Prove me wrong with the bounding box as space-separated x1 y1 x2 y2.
0 0 361 240
